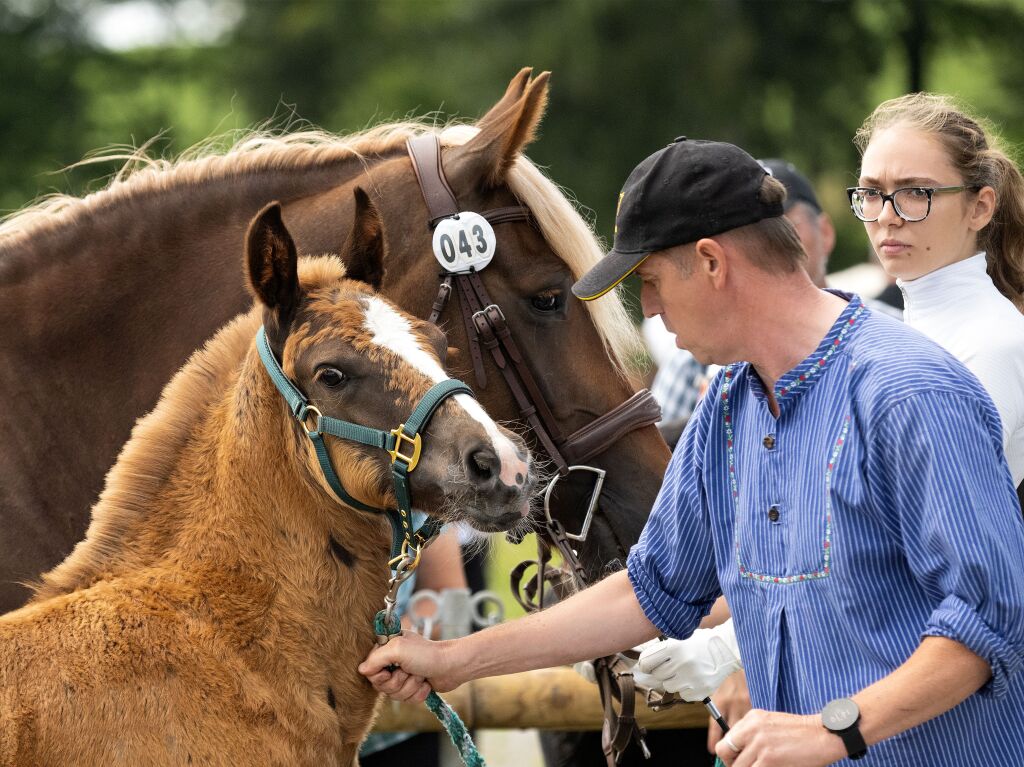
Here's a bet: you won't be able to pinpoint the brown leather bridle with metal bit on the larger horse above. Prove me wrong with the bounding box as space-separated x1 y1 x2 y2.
407 133 662 767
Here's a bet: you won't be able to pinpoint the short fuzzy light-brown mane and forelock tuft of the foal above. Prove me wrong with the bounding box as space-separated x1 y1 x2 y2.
32 256 345 601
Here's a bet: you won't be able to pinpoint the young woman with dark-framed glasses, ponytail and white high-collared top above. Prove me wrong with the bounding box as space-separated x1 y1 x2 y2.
847 93 1024 486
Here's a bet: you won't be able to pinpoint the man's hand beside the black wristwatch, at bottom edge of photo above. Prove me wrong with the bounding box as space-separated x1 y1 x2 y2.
715 709 847 767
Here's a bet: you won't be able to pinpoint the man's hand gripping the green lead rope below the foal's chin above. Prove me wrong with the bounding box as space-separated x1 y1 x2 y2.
359 633 465 702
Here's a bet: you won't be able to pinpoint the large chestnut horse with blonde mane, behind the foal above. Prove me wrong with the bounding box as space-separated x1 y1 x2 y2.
0 70 669 609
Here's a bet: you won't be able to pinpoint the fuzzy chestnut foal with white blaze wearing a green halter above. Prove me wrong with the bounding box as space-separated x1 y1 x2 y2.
0 200 532 767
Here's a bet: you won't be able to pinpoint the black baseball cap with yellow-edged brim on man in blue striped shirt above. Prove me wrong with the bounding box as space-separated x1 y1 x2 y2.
572 136 782 301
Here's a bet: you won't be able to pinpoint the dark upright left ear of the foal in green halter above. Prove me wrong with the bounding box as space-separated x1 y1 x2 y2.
246 202 300 331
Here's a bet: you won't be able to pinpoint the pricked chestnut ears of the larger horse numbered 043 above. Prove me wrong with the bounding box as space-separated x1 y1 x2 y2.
447 70 550 186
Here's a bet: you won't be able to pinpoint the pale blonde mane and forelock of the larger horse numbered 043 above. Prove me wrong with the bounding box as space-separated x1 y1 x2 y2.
0 121 643 388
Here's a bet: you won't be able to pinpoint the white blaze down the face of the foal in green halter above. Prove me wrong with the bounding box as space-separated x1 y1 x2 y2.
365 296 528 486
